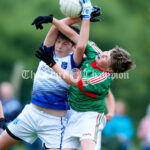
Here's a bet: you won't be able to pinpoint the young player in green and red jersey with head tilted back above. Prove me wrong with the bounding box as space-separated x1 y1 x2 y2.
35 39 134 150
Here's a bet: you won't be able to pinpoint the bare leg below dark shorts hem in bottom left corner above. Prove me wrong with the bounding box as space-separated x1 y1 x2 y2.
0 130 19 150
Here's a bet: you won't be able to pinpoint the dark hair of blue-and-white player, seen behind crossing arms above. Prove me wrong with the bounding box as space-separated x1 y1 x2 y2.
58 24 80 45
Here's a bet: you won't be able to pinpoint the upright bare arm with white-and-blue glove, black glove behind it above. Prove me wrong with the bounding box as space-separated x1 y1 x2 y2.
74 0 100 64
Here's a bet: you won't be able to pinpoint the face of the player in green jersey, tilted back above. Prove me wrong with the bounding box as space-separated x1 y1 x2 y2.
95 50 112 72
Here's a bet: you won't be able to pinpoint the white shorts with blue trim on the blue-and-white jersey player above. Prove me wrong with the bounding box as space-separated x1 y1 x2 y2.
7 104 67 148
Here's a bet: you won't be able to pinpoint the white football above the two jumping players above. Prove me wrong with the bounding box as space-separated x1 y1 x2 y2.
59 0 82 18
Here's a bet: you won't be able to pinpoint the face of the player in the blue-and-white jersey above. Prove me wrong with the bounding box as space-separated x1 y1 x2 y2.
55 37 72 57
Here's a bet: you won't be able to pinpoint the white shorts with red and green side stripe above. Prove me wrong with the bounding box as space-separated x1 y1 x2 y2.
62 110 106 149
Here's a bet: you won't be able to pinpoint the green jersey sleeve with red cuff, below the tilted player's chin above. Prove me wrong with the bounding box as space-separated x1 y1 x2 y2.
78 72 111 98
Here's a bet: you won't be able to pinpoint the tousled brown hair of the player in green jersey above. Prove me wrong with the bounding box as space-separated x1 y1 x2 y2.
110 46 136 73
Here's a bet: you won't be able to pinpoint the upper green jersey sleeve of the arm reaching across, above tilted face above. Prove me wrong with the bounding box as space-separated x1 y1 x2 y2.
85 41 102 59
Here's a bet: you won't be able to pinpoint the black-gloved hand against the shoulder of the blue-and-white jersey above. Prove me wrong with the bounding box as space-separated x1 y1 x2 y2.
35 46 56 67
